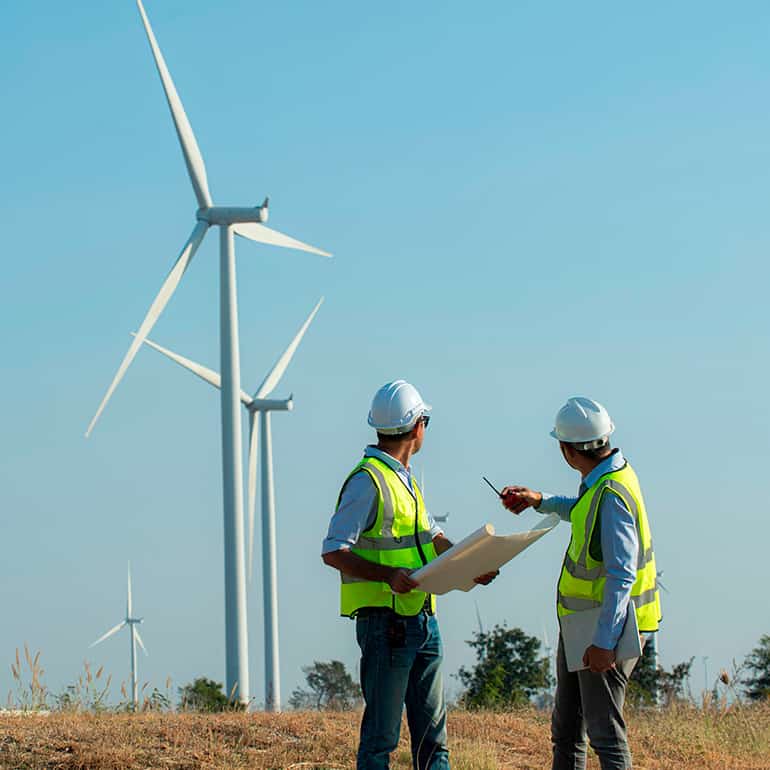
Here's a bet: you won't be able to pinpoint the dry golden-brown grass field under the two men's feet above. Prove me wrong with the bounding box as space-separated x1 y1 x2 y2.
0 704 770 770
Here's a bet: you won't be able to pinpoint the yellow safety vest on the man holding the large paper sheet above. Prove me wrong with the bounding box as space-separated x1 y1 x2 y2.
338 457 436 617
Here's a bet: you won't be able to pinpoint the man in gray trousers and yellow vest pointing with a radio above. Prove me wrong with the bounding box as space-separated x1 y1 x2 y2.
502 397 661 770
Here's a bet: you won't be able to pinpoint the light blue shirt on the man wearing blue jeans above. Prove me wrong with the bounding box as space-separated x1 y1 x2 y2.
321 446 444 555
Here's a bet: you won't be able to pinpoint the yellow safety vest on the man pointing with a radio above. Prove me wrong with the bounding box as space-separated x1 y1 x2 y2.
557 464 661 632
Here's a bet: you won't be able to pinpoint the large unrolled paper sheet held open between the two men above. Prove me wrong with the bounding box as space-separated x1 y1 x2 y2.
411 514 560 594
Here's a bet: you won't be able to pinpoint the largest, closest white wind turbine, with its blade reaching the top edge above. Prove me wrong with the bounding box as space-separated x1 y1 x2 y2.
86 0 330 704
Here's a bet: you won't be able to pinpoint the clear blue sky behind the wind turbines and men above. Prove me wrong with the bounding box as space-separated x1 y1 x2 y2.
0 0 770 699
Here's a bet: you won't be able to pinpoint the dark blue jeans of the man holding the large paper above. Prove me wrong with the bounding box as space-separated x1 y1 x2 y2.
356 610 449 770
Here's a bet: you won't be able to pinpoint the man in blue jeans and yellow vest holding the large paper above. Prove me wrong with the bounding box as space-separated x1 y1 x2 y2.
322 380 497 770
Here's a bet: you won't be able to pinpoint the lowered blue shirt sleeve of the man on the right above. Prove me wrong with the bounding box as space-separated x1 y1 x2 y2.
593 492 639 650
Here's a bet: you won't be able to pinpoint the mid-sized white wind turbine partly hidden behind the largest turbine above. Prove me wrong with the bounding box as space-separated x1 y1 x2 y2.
135 297 323 711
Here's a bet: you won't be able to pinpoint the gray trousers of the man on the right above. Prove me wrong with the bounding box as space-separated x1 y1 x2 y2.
551 637 638 770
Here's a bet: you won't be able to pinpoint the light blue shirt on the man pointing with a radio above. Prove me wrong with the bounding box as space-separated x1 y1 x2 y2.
537 449 639 650
